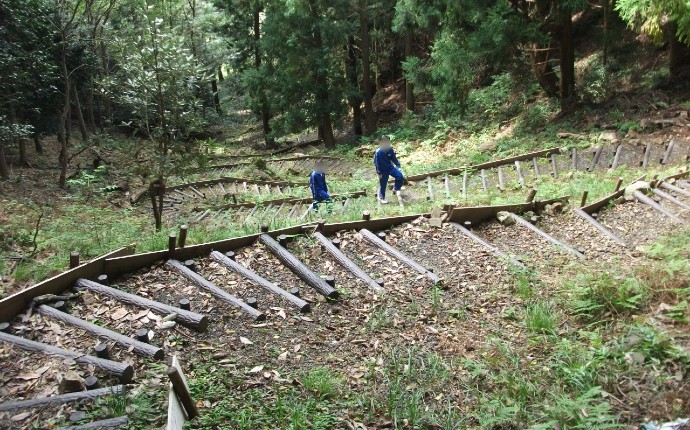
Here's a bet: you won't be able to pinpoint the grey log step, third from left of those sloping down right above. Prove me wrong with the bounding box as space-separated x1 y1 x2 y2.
76 279 208 332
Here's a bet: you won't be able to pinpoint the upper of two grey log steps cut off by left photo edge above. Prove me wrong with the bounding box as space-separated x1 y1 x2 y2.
0 333 134 384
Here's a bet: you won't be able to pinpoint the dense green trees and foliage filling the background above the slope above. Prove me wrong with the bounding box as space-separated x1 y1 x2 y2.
0 0 690 222
